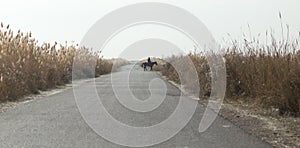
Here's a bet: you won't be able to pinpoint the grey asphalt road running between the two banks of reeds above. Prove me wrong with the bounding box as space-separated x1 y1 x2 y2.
0 65 271 148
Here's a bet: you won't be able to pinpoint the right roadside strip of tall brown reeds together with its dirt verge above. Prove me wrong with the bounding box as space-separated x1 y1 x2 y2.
154 24 300 147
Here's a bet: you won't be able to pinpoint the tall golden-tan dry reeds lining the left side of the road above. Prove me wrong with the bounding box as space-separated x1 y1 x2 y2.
0 23 126 101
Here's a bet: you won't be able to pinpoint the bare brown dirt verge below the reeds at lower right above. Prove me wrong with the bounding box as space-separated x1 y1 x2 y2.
219 102 300 147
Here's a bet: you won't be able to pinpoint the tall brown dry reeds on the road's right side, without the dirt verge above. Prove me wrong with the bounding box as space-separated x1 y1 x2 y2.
157 35 300 116
